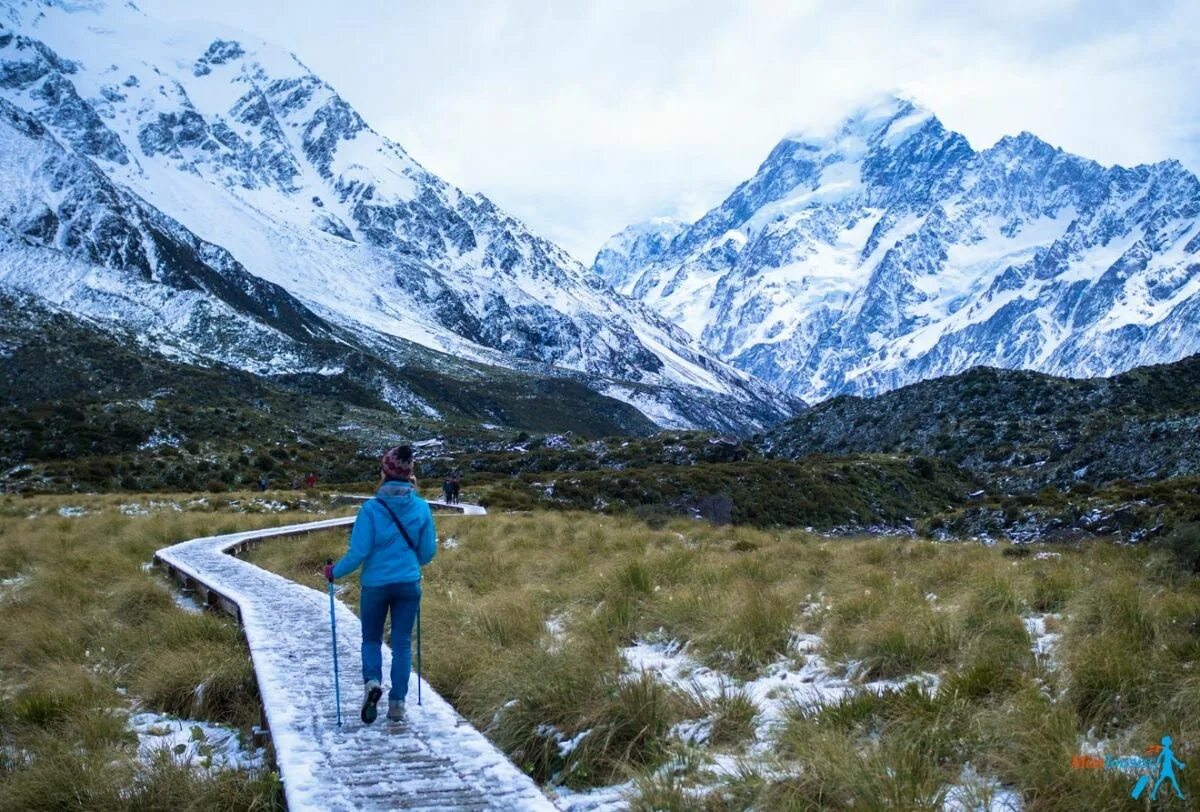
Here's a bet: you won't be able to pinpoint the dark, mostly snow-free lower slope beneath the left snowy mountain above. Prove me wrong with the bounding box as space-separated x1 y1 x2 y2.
0 288 676 491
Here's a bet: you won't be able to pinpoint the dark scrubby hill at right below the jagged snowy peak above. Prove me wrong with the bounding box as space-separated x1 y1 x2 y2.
763 355 1200 489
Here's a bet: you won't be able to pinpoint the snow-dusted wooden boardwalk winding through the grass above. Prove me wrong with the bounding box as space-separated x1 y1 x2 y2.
156 503 554 812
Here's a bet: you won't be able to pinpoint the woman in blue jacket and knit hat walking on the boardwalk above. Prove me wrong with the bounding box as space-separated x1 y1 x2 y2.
325 445 437 724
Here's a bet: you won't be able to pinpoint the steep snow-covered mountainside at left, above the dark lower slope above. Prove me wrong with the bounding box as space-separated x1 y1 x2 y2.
0 0 796 429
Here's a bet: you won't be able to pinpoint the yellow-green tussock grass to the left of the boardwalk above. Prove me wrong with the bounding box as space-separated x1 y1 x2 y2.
0 494 343 811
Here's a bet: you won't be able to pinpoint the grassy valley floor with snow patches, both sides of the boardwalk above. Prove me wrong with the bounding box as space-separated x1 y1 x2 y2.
0 493 1200 810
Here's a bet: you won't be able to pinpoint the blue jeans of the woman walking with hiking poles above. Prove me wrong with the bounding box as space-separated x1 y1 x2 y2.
359 581 421 700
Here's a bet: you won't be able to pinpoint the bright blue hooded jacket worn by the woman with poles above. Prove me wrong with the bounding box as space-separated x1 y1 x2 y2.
334 481 438 587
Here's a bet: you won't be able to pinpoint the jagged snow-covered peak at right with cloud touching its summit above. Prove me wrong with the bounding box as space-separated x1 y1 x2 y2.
594 97 1200 399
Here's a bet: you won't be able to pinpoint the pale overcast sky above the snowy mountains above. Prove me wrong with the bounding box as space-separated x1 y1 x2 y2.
139 0 1200 264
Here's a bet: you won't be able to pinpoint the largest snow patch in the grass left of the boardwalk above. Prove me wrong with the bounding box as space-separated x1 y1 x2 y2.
130 712 265 771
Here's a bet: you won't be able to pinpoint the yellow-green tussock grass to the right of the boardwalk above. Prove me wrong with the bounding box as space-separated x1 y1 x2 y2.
252 512 1200 811
